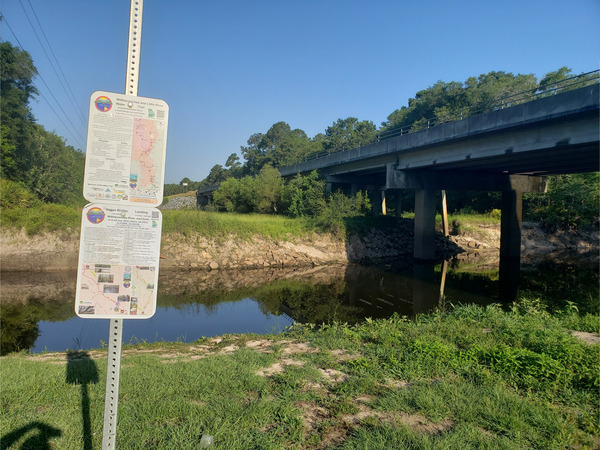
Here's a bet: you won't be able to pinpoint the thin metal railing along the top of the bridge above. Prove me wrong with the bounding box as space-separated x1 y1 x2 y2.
303 70 600 162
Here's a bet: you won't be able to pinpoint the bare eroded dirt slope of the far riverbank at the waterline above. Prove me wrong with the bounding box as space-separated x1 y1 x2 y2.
0 219 599 272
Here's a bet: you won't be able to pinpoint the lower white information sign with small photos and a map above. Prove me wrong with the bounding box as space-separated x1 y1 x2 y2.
75 204 162 319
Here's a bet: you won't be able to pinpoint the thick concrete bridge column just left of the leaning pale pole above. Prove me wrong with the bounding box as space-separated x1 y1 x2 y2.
414 189 436 262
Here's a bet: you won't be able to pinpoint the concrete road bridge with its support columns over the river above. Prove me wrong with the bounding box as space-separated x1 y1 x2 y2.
280 84 600 300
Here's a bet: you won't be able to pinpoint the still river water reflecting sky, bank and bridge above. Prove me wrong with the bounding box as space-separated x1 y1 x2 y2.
0 263 598 354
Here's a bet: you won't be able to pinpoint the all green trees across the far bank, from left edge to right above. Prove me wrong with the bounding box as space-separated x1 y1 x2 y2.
0 42 600 232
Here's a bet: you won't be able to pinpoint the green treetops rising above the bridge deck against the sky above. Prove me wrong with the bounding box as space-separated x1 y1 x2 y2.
185 67 597 187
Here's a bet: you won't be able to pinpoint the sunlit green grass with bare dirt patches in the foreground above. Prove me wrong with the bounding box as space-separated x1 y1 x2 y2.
0 305 600 449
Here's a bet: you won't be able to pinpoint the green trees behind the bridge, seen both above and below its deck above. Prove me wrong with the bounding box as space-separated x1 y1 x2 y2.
174 67 599 232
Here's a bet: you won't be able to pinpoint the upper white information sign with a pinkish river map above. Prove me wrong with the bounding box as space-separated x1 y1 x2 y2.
83 91 169 207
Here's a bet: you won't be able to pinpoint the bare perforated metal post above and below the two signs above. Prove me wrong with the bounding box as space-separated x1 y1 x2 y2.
102 0 144 450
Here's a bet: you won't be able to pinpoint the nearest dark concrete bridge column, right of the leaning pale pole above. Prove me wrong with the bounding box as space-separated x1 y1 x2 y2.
499 190 523 302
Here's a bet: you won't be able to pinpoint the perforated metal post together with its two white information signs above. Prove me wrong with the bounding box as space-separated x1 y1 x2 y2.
75 0 169 449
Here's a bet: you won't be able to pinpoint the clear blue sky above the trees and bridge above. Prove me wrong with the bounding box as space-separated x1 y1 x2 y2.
0 0 600 183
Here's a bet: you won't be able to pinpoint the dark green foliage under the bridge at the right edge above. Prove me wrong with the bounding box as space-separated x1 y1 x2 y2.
524 172 600 231
